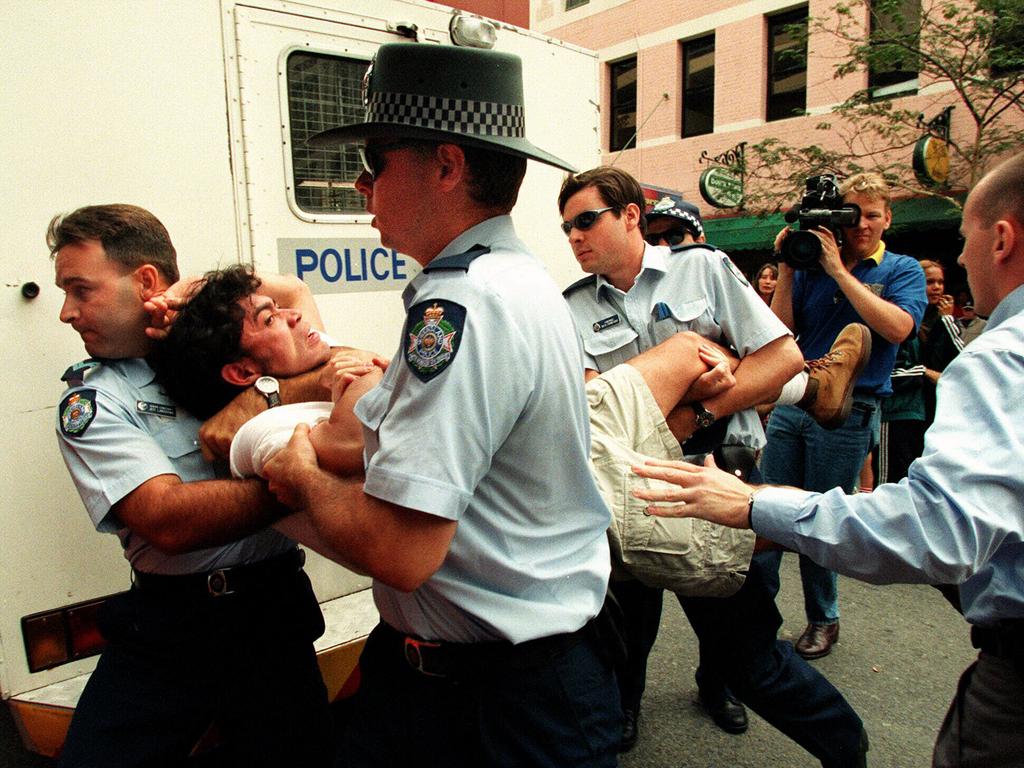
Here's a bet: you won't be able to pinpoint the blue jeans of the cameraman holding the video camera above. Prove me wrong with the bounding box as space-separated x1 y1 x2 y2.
761 396 881 624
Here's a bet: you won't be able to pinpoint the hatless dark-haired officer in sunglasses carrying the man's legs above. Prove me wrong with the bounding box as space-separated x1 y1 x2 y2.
558 167 866 765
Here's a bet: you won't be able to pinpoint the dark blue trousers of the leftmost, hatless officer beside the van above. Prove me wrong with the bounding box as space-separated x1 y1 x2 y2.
59 568 333 768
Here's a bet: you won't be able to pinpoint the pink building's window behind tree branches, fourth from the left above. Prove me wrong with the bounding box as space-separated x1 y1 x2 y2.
867 0 921 98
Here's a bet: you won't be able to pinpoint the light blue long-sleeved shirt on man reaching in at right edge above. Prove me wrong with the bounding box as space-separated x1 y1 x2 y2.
752 287 1024 626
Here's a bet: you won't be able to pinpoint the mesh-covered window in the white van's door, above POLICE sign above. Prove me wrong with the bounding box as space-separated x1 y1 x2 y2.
288 51 367 213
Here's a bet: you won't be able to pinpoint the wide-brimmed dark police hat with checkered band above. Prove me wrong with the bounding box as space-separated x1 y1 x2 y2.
307 43 575 172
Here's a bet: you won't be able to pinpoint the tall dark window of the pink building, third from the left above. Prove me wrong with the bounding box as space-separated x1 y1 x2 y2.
767 7 807 120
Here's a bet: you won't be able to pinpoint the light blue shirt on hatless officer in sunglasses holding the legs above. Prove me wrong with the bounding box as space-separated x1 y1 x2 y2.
565 245 790 449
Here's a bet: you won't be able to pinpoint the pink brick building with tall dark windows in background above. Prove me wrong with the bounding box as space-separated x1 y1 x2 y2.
530 0 1019 288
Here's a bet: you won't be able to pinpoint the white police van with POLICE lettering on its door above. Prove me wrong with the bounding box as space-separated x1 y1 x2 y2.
0 0 600 755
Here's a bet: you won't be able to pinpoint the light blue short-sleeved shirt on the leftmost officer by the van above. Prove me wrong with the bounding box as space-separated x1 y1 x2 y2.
56 358 295 575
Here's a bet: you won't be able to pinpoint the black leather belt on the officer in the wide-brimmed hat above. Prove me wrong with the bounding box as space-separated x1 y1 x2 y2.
377 624 590 678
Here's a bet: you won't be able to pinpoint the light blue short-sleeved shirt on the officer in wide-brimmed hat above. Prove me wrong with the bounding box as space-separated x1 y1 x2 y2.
355 216 611 643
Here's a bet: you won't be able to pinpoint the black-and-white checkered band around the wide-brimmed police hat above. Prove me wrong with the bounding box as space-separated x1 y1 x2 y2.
367 93 526 138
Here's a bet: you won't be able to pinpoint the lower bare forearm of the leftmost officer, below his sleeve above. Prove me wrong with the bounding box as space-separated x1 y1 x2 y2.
112 474 287 555
